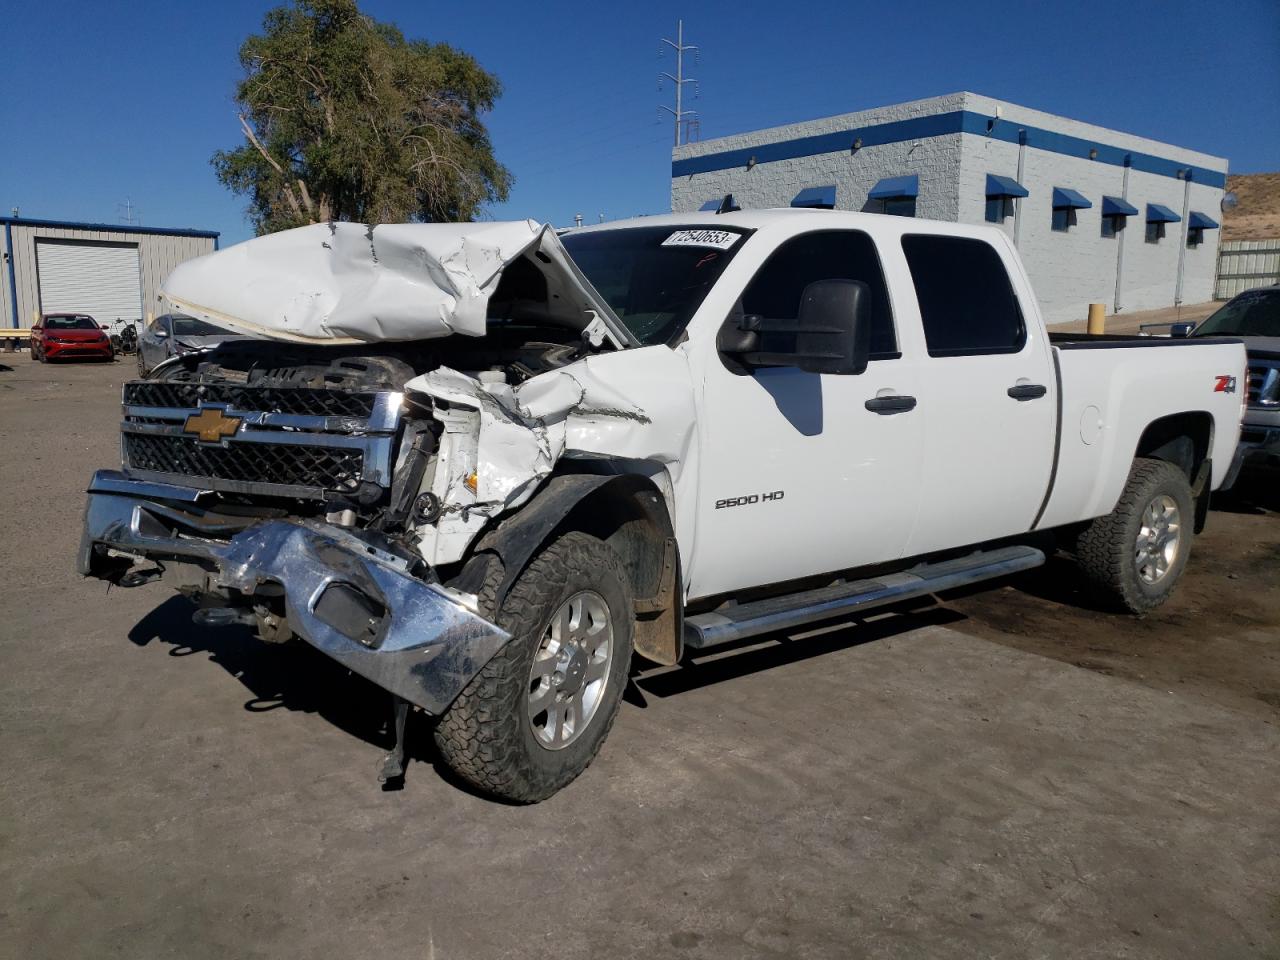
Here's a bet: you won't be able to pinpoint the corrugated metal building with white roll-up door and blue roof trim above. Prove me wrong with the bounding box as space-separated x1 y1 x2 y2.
0 216 218 335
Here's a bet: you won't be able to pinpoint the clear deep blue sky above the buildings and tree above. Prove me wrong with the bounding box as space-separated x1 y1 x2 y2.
0 0 1280 243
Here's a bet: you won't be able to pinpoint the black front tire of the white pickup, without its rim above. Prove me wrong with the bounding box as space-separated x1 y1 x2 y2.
435 532 634 804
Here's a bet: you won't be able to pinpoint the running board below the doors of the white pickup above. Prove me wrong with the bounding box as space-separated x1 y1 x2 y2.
685 547 1044 650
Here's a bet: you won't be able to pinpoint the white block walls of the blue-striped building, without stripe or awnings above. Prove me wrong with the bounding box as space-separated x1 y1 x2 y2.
671 93 1228 323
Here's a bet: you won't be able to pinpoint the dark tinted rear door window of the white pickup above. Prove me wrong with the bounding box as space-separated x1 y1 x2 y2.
902 234 1027 357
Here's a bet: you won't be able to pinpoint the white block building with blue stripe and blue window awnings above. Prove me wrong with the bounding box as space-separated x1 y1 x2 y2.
671 92 1228 323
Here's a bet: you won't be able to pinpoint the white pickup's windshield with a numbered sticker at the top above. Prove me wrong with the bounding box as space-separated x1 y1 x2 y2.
561 227 746 344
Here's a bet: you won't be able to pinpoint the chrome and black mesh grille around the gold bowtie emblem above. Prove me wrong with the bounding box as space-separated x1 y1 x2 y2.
120 380 402 502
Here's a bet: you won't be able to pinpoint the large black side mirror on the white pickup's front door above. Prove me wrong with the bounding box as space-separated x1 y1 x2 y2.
718 280 872 374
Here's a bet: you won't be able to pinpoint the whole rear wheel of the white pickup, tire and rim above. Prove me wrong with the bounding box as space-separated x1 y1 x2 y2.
1075 458 1196 613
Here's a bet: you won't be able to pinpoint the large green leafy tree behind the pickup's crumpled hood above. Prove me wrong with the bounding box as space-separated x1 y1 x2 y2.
212 0 512 234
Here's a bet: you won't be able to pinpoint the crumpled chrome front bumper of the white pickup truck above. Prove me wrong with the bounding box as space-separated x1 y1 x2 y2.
77 470 511 714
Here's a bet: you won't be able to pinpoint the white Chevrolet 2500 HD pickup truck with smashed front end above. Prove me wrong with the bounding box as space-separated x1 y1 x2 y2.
78 210 1245 801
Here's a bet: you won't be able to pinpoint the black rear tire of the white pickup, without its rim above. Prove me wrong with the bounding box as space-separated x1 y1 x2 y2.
1075 458 1196 613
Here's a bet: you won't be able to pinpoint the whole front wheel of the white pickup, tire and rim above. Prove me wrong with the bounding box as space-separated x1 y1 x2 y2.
435 532 634 804
